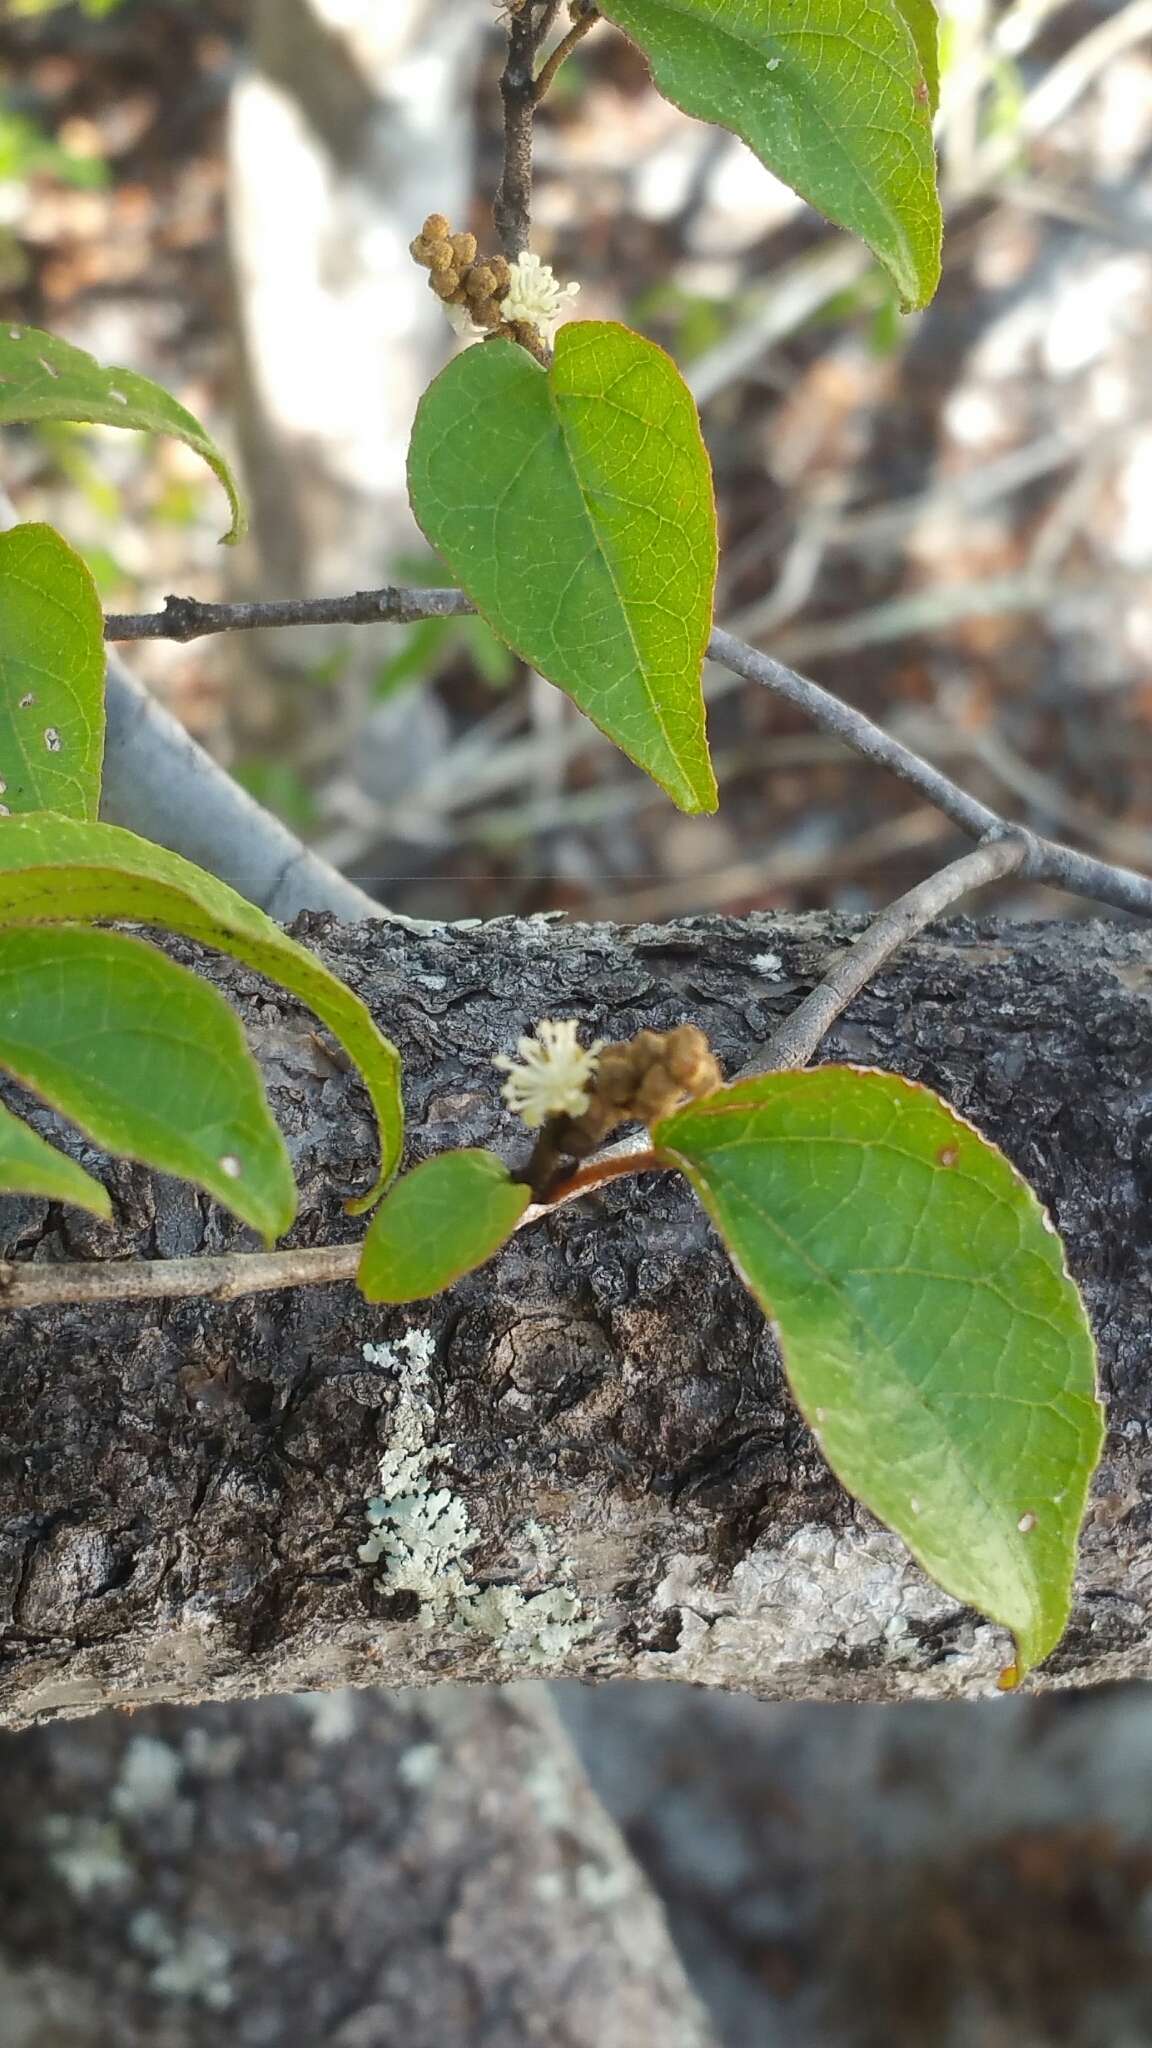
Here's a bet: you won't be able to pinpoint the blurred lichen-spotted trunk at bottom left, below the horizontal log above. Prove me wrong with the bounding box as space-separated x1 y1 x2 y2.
0 1688 713 2048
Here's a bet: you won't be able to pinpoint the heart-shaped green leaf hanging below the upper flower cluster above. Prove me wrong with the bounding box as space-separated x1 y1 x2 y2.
408 319 715 811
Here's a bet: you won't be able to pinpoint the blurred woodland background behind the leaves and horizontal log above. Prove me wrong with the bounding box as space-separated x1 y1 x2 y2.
0 0 1152 2048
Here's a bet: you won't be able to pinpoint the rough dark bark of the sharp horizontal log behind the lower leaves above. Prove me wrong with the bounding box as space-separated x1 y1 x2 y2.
0 918 1152 1724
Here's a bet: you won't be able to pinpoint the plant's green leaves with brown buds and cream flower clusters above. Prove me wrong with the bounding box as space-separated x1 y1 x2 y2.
0 0 1101 1683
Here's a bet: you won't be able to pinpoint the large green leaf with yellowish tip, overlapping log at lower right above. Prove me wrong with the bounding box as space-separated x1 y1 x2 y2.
652 1067 1101 1675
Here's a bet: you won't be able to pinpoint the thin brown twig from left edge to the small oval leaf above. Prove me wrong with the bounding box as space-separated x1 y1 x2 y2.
0 1245 363 1309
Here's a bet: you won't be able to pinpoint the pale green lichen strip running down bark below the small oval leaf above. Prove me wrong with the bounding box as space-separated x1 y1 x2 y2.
357 1329 594 1665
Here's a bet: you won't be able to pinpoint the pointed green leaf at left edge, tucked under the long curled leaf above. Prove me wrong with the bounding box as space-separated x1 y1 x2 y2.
0 926 295 1243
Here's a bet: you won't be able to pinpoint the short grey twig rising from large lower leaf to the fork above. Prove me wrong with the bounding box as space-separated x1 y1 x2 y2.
734 838 1029 1081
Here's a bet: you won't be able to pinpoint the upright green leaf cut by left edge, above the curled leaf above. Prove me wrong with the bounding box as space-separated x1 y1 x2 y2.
0 524 105 819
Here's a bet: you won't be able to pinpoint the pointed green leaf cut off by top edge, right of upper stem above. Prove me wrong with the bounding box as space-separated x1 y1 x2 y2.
603 0 941 305
